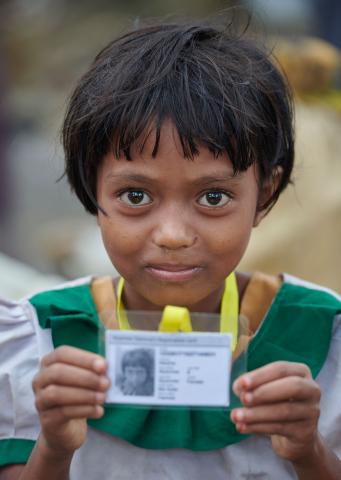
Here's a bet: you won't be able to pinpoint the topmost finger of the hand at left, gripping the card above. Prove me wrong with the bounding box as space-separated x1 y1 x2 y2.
41 345 107 373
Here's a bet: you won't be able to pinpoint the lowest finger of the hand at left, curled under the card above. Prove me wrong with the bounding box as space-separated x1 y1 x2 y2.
40 405 104 428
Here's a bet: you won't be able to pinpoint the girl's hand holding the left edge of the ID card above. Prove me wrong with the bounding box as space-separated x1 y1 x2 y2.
33 346 109 455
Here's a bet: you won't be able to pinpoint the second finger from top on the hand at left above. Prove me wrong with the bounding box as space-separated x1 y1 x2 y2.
32 363 110 392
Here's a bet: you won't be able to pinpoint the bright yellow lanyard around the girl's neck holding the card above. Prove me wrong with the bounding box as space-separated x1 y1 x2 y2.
117 272 239 351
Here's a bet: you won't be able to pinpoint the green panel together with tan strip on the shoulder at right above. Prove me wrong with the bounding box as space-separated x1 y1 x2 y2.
241 274 341 378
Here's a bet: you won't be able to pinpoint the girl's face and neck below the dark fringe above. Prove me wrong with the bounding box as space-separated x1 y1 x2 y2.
97 123 262 312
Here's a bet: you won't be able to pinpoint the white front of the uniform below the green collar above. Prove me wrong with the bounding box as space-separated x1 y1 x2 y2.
70 430 296 480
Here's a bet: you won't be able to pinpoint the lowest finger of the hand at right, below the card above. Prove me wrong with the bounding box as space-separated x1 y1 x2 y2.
236 420 315 439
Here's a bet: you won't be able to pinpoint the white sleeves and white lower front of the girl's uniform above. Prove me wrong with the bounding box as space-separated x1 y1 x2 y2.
0 279 341 480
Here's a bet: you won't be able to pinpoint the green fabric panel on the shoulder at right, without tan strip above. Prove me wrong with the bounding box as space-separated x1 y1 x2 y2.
248 283 341 378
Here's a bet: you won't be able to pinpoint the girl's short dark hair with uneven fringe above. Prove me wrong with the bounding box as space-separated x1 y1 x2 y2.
62 22 294 214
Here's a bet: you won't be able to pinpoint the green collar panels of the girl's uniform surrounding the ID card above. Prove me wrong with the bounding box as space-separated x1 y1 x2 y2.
31 284 341 451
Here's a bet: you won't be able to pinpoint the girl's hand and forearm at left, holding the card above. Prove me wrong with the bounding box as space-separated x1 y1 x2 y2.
0 346 109 480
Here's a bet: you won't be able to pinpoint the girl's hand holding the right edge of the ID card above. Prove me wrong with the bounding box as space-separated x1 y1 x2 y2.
231 362 321 462
